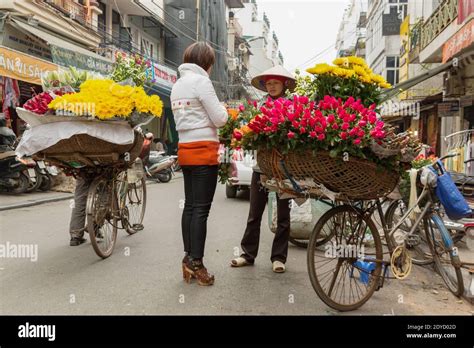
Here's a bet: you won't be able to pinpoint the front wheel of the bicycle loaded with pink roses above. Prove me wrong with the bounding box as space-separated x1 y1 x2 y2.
424 214 464 296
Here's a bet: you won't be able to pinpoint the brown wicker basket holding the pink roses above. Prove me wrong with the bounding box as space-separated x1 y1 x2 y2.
257 150 399 200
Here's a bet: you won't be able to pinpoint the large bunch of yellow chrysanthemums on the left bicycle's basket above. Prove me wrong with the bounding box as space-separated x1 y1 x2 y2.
48 80 163 120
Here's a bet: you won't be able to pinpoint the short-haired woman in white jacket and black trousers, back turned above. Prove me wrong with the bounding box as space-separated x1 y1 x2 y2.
171 42 228 285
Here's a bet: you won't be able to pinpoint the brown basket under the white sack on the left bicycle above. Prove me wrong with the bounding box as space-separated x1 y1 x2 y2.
33 132 144 167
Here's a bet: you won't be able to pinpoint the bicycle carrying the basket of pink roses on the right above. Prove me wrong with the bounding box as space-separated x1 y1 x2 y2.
307 155 464 311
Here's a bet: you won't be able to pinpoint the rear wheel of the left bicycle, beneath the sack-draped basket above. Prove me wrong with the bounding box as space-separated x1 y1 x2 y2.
86 177 117 259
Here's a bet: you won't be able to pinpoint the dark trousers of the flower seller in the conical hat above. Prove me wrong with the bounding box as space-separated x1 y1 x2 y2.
241 172 290 263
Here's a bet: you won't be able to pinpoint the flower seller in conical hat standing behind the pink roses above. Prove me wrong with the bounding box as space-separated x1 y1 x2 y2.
231 66 296 273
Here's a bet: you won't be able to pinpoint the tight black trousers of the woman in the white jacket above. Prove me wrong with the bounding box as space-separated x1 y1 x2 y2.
181 166 217 259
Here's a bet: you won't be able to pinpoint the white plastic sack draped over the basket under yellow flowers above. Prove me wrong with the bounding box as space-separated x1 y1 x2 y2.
16 121 134 158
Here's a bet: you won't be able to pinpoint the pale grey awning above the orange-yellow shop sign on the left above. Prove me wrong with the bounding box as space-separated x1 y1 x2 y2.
12 19 112 74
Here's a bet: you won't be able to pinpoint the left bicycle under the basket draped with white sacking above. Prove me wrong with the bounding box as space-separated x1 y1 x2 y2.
86 161 146 259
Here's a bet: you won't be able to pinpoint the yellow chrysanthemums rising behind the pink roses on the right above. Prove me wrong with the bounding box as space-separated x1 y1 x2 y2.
306 56 392 88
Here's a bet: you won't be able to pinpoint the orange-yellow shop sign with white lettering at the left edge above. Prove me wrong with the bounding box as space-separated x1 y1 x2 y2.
0 46 58 85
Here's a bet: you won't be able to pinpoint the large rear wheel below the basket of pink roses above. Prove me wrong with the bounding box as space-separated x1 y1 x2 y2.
307 205 383 311
